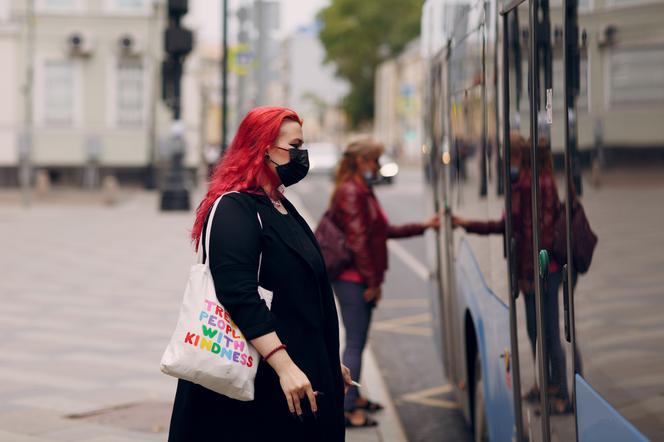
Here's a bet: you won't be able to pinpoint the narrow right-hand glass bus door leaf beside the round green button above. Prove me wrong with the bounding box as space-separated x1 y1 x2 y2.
528 0 580 440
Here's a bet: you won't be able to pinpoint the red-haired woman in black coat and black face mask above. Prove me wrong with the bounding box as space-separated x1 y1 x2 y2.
169 107 351 441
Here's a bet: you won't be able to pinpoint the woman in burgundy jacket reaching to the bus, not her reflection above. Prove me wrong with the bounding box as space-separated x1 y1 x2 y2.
331 139 440 427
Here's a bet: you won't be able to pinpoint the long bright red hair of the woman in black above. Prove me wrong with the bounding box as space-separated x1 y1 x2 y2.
191 106 302 247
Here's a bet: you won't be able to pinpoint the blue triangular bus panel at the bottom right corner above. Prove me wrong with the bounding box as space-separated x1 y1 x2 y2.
575 374 648 442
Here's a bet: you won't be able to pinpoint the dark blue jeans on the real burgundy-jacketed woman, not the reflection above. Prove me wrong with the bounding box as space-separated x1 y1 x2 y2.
332 281 374 411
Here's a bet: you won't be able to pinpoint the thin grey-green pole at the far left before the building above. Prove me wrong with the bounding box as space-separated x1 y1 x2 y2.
18 0 35 207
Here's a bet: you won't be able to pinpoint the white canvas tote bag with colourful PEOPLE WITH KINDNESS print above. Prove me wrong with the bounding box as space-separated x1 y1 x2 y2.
161 192 272 401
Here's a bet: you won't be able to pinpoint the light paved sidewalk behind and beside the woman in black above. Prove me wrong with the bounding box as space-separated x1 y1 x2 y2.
0 192 405 442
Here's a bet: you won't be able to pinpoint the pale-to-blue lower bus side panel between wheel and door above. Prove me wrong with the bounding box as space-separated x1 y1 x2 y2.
456 241 514 440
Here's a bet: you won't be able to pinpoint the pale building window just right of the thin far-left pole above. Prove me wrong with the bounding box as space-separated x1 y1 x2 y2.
44 60 74 126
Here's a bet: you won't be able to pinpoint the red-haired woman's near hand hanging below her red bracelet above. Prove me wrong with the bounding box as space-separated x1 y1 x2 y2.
270 351 318 416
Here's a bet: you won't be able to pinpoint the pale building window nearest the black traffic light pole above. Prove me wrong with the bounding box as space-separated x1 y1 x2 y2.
115 59 145 126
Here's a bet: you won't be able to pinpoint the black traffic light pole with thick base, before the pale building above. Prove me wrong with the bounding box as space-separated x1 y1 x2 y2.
161 0 193 211
